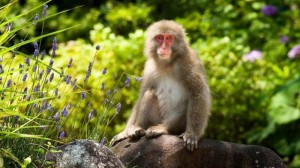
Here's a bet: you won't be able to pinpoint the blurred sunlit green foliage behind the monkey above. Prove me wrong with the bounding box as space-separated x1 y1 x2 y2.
0 0 300 167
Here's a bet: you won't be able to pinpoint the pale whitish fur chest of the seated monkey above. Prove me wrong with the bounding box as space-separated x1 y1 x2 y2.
156 77 187 117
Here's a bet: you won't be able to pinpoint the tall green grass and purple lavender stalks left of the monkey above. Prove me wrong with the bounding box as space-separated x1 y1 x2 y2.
0 1 121 167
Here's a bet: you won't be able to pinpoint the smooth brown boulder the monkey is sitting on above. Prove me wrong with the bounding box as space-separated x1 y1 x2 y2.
112 135 285 168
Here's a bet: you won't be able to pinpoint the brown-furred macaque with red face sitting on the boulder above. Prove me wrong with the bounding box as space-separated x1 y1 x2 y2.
111 20 211 151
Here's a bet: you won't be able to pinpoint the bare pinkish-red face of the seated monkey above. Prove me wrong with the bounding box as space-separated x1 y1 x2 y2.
155 34 174 59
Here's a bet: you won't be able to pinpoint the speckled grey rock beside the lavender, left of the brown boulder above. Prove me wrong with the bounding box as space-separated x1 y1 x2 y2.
46 140 124 168
